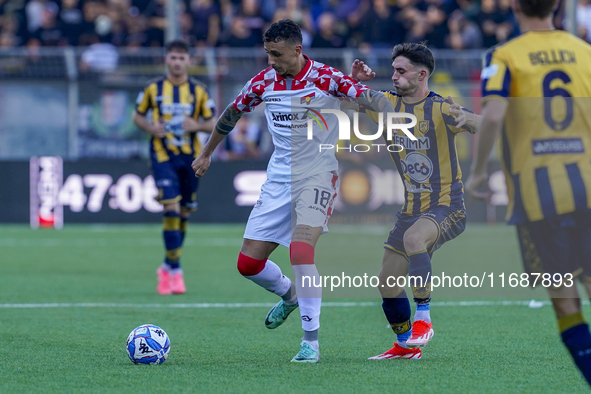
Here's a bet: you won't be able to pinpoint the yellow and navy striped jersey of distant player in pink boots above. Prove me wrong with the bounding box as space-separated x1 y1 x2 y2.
136 77 214 163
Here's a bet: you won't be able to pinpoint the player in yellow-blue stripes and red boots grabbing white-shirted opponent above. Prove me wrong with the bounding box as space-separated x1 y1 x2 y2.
352 43 479 360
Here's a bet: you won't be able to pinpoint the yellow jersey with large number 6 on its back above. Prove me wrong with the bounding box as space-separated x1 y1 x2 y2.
481 30 591 224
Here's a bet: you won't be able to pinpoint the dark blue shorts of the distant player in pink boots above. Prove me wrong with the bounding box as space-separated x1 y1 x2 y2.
151 154 199 211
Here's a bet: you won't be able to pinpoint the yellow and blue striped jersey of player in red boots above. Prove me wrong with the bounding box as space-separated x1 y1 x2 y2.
367 91 473 215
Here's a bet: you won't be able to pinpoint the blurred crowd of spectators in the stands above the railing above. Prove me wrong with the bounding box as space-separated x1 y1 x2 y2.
0 0 591 49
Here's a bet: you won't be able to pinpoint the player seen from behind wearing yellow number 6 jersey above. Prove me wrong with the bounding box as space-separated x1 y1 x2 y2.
466 0 591 384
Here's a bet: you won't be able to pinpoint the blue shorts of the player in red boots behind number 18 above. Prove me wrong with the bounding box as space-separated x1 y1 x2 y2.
384 205 466 259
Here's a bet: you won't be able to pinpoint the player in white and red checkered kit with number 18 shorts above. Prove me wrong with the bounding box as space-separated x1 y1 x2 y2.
192 19 394 363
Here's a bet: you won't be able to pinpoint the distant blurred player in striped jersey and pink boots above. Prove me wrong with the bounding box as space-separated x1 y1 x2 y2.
133 41 215 295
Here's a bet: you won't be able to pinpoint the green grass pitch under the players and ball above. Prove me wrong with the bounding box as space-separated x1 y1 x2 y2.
0 225 590 393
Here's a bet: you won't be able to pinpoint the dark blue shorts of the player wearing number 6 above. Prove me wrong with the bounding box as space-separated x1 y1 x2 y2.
517 210 591 283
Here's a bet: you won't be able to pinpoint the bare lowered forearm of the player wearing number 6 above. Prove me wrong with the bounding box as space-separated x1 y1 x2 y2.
466 99 508 201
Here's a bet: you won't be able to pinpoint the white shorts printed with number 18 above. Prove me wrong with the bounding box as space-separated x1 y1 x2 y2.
244 171 339 247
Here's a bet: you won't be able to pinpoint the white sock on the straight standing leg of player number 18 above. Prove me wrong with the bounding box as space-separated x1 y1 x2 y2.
292 264 322 331
